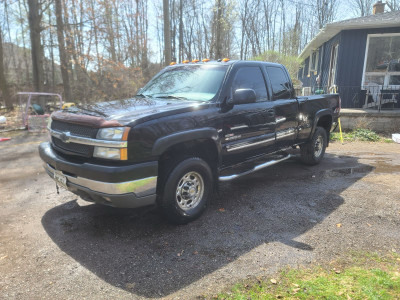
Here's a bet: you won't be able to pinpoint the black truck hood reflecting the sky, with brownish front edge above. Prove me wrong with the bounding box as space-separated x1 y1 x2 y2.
53 96 209 125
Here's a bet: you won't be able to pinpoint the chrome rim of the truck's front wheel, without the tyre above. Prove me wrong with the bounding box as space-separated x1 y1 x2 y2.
176 171 204 210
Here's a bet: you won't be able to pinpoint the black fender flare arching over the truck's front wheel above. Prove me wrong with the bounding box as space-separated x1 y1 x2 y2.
151 127 222 160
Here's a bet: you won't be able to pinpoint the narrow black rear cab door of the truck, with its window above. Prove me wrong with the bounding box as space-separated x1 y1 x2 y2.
264 65 299 149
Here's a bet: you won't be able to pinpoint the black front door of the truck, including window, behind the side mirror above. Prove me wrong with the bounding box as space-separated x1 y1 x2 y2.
222 63 275 166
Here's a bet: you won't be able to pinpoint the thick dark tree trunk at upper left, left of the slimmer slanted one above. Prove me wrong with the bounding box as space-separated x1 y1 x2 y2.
28 0 44 92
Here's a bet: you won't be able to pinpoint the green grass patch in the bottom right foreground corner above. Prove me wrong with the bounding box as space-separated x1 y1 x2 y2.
214 253 400 300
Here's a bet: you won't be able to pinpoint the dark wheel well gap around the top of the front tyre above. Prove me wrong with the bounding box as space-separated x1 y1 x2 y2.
157 139 219 191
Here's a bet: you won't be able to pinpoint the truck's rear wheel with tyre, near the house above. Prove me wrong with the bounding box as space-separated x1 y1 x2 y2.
300 127 328 165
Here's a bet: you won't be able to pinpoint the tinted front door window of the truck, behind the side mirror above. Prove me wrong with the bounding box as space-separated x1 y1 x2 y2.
232 67 268 102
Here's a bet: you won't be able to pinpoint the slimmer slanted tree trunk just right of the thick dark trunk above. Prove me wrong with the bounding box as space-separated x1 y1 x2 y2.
55 0 72 102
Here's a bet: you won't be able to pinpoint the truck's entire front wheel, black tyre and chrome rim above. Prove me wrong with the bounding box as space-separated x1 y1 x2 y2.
158 157 213 224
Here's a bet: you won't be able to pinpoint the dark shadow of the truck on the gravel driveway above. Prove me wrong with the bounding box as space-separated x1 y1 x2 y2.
42 154 373 297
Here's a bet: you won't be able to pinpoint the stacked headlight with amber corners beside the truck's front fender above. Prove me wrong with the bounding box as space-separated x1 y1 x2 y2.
93 127 130 160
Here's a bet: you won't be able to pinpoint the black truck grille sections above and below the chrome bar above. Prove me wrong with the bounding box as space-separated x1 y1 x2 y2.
51 120 98 157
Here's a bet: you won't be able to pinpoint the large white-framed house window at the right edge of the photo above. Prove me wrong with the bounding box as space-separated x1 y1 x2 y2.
362 33 400 86
